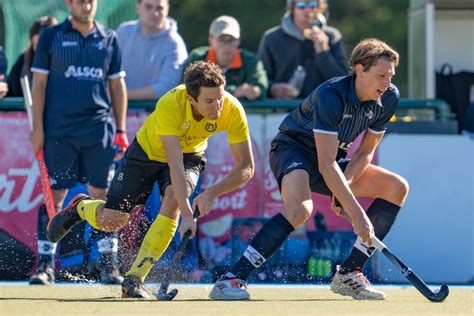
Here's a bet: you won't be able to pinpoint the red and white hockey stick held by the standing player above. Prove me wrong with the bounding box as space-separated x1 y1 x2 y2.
20 76 56 220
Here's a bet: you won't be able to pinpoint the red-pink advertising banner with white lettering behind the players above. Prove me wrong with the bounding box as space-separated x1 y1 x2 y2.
0 112 378 266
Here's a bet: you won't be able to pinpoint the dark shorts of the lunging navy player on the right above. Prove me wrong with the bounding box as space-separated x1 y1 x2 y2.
270 140 350 196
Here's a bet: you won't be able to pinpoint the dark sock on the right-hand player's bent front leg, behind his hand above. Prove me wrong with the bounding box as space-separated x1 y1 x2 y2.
339 199 400 274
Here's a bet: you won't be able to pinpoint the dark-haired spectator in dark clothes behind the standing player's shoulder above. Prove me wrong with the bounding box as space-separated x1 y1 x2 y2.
7 16 58 97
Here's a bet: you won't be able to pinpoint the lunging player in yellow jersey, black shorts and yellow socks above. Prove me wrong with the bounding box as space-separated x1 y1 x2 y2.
48 61 254 298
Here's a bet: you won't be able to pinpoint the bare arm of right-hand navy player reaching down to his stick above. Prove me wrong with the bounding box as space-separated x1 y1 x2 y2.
314 132 374 245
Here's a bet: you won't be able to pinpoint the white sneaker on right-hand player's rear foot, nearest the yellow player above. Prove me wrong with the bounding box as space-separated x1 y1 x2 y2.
209 273 250 301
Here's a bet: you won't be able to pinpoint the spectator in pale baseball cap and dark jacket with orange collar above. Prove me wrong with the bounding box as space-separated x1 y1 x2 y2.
186 15 268 101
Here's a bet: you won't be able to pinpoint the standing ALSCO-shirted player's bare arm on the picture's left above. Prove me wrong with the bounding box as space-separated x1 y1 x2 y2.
30 72 48 153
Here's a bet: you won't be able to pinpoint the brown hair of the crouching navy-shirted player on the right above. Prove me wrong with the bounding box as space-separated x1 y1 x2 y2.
349 38 400 73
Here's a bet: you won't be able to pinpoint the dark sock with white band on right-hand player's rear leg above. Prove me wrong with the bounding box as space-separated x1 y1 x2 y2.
230 214 295 280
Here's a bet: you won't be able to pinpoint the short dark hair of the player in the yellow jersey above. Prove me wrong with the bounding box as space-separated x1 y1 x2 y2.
184 61 225 101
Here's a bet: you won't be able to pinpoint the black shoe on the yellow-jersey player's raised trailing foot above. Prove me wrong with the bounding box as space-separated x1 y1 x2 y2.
46 193 91 242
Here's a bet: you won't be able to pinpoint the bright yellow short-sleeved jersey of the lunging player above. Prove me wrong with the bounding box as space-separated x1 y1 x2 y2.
137 85 249 162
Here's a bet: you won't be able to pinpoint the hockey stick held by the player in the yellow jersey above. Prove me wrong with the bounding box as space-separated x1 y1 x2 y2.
155 205 200 301
